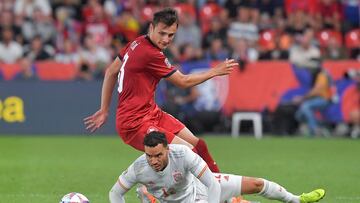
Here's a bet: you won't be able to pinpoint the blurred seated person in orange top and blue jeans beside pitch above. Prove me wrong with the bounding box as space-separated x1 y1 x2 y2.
294 59 335 136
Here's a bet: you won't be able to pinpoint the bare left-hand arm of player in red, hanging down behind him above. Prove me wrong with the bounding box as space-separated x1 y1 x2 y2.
84 57 122 132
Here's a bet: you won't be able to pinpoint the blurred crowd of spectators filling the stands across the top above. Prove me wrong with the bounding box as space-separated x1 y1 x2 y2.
0 0 360 80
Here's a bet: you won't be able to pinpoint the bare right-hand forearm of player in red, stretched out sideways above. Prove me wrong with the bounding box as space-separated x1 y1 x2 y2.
166 59 239 88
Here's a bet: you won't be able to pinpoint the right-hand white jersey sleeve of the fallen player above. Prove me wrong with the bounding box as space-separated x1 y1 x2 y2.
184 147 208 178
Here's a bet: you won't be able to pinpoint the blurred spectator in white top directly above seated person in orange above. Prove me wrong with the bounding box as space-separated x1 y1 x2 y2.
290 28 320 69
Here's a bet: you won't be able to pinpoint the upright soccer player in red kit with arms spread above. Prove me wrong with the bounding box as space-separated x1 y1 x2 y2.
84 8 238 172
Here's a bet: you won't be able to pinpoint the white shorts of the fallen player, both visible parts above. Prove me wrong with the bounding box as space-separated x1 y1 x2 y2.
195 173 242 203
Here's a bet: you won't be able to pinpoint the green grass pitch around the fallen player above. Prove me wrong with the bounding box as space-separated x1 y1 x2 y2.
0 135 360 203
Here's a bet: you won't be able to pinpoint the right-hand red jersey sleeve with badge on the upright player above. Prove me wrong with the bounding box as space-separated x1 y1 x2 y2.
148 51 176 78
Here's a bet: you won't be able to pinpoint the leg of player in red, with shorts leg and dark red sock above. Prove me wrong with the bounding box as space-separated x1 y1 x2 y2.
158 112 219 173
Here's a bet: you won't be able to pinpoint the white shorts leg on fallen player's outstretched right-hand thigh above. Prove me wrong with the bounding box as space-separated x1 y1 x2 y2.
214 173 243 201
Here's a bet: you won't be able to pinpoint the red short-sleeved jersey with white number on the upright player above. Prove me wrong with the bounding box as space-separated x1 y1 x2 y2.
116 36 176 130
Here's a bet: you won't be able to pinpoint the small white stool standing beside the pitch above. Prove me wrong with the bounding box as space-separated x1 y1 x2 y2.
231 112 262 139
